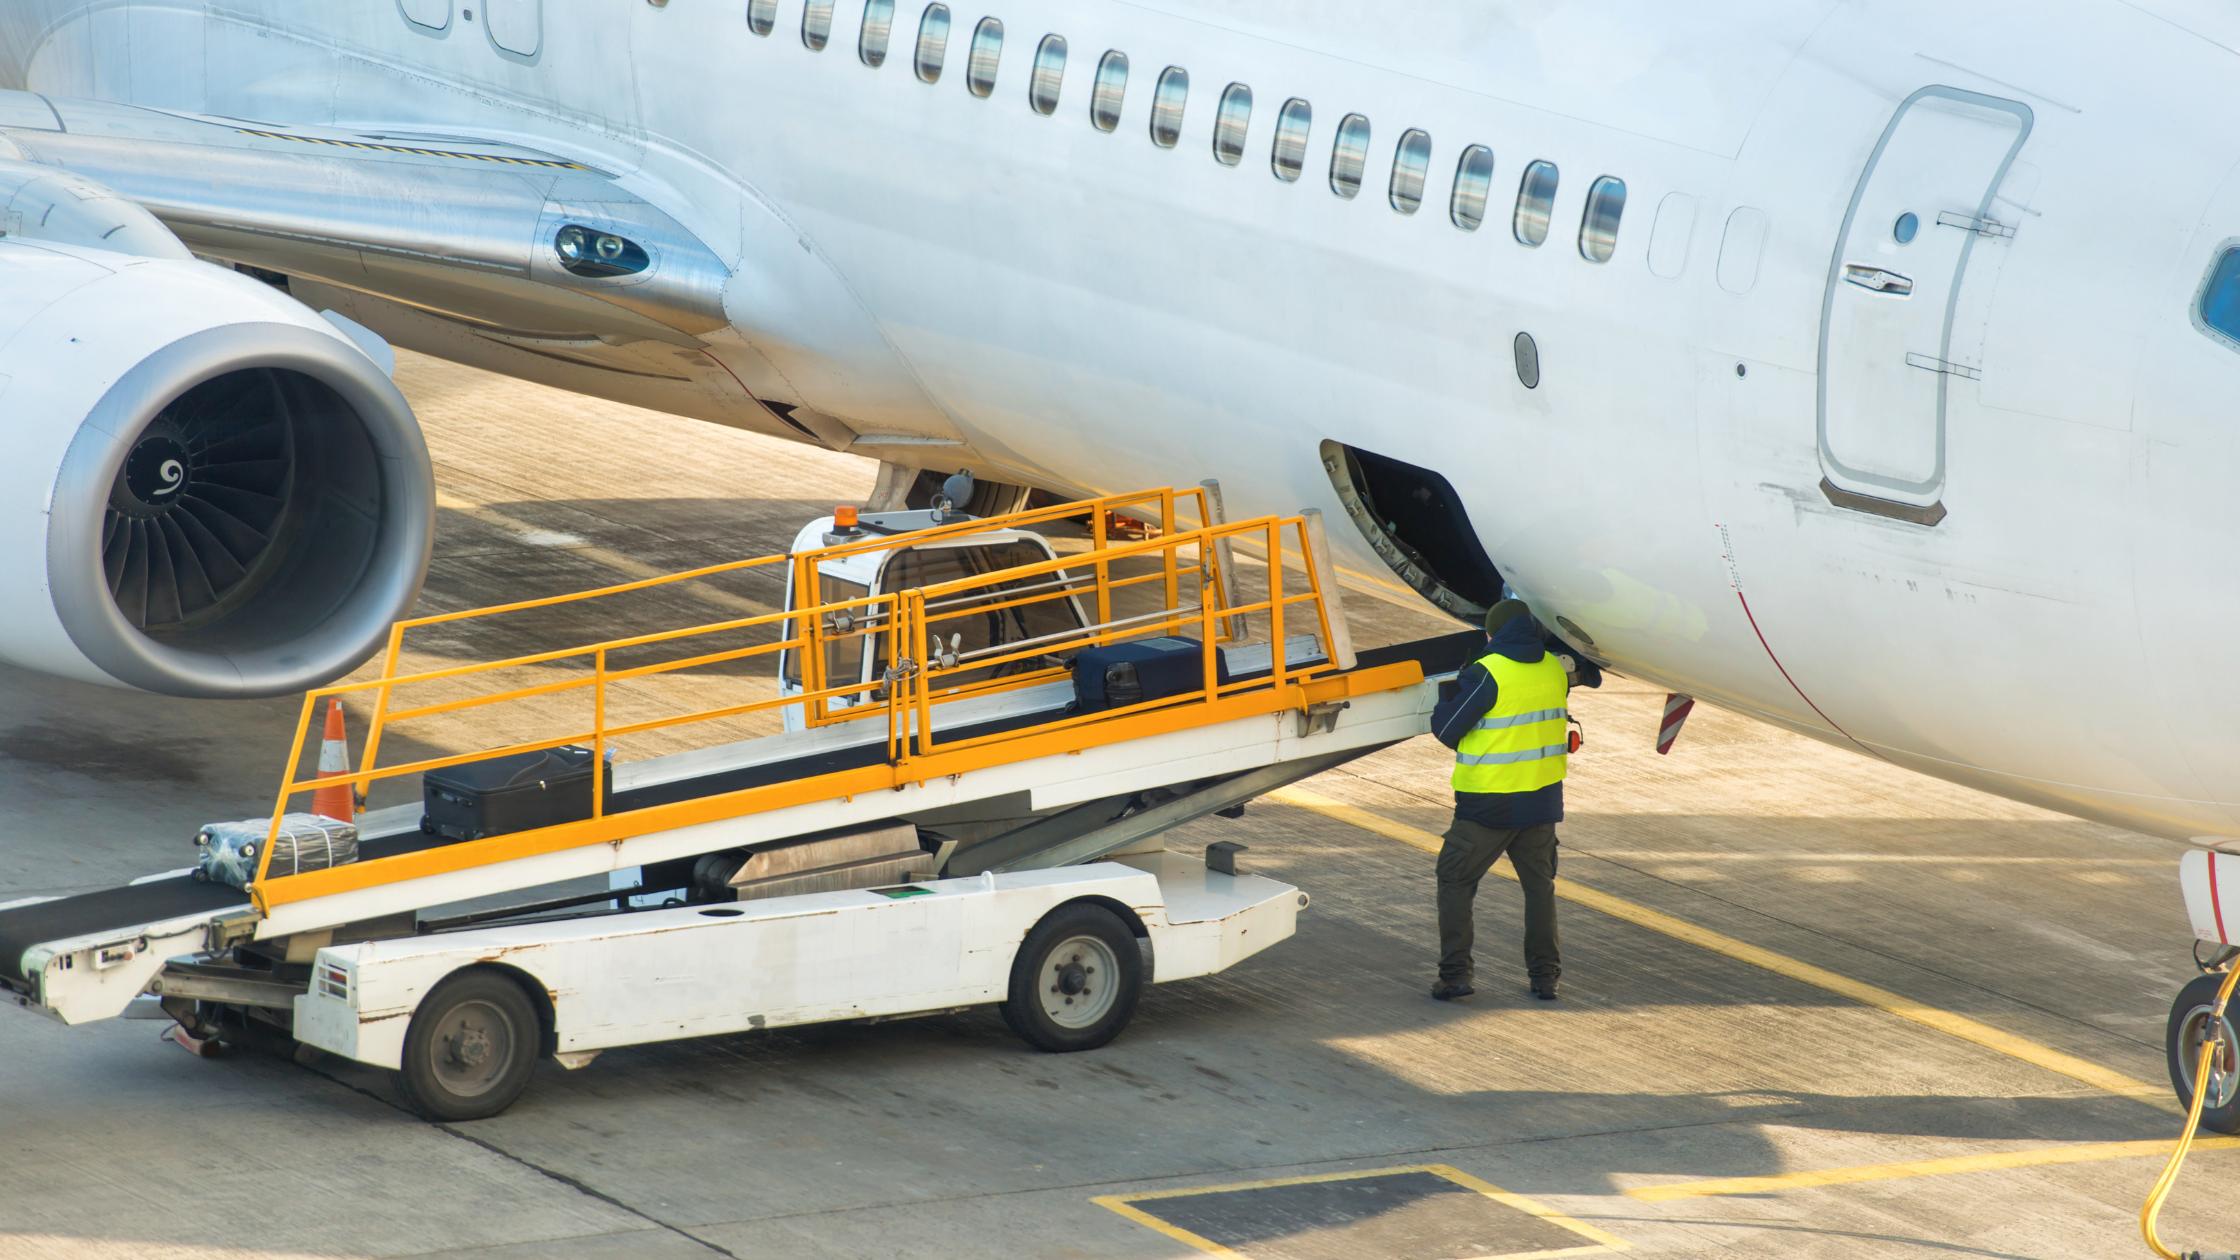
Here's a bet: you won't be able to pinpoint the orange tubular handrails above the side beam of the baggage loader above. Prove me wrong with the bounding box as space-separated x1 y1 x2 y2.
251 489 1333 912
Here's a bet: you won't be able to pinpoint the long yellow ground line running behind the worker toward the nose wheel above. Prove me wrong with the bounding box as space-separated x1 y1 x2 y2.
1268 787 2164 1099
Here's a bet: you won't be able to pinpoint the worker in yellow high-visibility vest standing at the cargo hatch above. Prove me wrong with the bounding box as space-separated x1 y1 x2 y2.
1431 599 1602 1002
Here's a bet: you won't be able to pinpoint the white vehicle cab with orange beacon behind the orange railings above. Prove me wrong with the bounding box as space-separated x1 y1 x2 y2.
777 511 1089 731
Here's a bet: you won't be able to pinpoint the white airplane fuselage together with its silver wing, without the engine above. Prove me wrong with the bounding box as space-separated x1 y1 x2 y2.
0 0 2240 839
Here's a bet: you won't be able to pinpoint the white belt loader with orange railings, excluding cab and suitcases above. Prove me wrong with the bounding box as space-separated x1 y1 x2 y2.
0 491 1478 1119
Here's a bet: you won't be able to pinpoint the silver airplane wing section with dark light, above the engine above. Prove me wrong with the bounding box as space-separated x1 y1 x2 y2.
0 92 730 348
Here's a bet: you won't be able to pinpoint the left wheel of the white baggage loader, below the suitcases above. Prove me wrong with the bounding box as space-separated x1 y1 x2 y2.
399 971 544 1121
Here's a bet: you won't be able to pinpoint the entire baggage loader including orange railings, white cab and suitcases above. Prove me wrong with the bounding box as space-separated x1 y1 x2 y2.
0 489 1481 1119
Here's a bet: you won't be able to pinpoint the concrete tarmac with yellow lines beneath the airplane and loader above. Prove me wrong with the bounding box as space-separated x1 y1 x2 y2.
0 354 2240 1260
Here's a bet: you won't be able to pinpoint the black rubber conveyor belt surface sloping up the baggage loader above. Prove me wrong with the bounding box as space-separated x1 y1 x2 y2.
0 630 1485 980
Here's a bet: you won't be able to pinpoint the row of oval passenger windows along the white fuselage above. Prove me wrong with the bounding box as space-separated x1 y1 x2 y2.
746 0 1626 262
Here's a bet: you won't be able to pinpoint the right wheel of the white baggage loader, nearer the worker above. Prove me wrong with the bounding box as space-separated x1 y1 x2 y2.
1001 901 1142 1054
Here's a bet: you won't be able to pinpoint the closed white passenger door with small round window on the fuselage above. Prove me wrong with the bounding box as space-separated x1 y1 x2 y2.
1819 87 2032 525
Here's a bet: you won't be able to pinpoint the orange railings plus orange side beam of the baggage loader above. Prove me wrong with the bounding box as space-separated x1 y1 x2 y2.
251 489 1420 912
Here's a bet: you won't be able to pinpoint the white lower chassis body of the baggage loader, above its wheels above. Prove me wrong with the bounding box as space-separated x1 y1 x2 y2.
296 852 1306 1067
